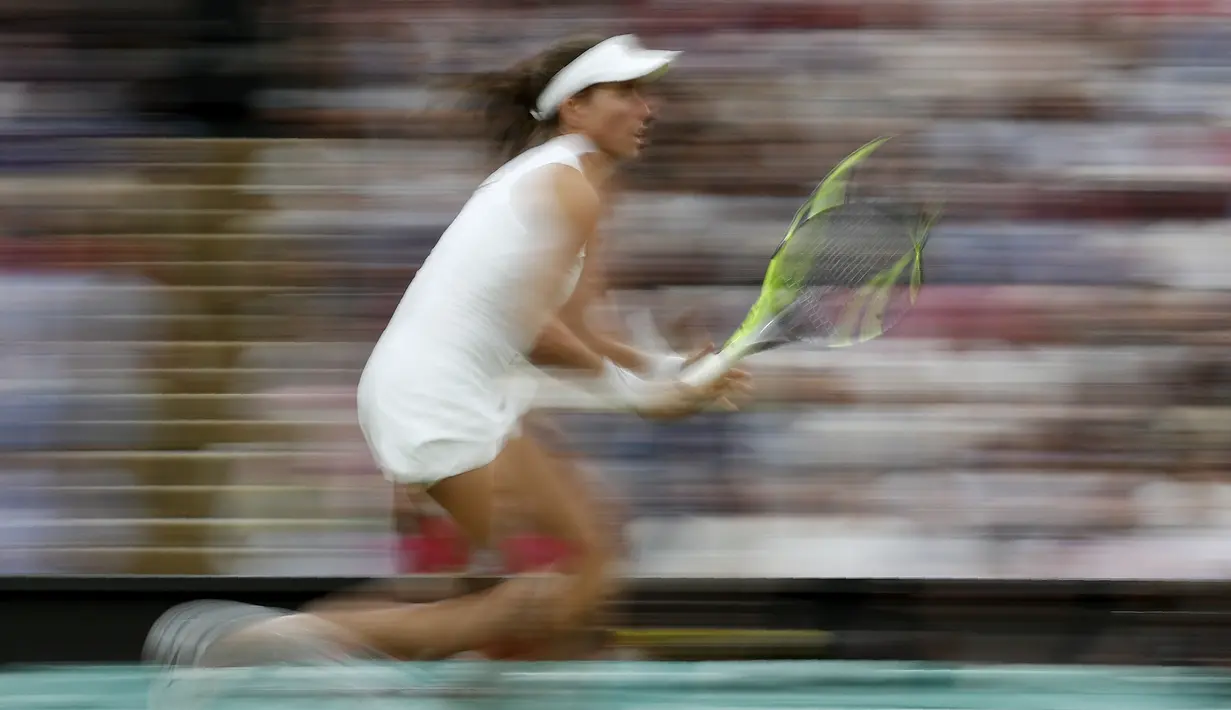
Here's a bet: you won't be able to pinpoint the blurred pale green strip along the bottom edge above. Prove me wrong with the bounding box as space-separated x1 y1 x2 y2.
0 662 1231 710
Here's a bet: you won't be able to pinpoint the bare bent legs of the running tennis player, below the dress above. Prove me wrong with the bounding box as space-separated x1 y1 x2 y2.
273 428 616 660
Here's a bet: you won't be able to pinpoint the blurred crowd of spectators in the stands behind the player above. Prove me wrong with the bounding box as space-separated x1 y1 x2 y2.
0 0 1231 578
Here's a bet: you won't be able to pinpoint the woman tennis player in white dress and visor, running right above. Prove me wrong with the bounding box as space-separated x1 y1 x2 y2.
148 36 745 663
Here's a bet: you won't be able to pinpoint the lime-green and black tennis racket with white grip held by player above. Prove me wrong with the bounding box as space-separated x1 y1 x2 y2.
682 138 938 388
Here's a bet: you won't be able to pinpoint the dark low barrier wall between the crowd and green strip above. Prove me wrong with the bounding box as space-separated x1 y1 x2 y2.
7 577 1231 664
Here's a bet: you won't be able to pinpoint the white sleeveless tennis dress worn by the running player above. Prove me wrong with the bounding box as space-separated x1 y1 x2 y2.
357 135 596 486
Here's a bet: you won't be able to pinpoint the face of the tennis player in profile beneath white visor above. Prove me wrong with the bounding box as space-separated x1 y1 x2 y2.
561 81 654 160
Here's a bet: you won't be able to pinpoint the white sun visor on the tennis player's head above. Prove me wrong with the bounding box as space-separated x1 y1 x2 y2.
531 34 680 121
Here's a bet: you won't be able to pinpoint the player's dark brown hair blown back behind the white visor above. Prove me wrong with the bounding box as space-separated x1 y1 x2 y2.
473 37 602 160
